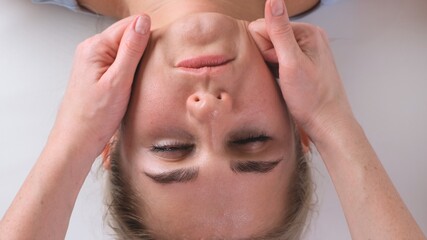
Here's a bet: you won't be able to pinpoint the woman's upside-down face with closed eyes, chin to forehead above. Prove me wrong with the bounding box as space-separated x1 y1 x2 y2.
121 13 295 239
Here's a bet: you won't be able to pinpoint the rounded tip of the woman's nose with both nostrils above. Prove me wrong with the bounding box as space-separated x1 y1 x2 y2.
187 91 232 122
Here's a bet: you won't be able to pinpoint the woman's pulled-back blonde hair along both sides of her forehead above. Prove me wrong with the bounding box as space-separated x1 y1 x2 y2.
106 127 313 240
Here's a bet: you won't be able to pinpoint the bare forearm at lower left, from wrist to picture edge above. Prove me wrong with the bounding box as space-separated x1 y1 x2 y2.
0 131 93 239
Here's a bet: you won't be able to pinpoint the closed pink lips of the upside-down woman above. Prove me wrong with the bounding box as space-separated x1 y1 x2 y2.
177 55 232 69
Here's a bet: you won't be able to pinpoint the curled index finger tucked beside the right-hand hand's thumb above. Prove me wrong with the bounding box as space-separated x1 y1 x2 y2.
248 19 277 63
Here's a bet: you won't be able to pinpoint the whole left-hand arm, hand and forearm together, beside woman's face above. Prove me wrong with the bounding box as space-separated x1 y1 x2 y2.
0 15 151 240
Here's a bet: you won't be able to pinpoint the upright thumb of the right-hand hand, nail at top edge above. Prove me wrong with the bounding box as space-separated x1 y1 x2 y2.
265 0 300 64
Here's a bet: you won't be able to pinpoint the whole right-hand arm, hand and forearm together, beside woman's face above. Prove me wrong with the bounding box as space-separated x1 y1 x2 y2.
249 0 425 236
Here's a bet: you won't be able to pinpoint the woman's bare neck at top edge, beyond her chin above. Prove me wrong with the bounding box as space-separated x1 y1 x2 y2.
124 0 265 29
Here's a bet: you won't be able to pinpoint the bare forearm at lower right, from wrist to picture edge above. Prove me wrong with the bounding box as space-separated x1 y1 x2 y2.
316 118 425 239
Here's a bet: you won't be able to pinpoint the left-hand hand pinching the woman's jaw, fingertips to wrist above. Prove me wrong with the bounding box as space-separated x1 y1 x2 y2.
50 15 150 160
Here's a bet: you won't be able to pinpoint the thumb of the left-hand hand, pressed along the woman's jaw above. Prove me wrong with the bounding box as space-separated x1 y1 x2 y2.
107 15 151 81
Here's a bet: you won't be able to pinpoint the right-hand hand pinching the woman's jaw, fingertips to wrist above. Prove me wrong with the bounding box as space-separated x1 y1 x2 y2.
249 0 352 143
